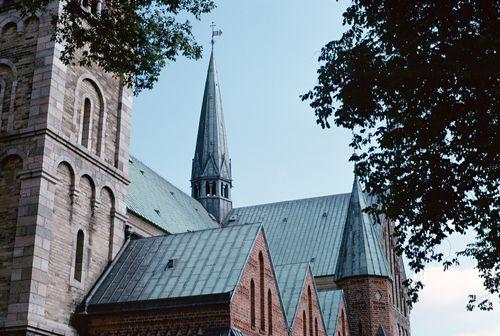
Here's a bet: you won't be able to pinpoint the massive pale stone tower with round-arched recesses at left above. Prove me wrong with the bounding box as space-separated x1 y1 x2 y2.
0 0 131 335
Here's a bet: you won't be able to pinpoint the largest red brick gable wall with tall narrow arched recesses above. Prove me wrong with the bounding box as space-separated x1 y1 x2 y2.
231 233 288 336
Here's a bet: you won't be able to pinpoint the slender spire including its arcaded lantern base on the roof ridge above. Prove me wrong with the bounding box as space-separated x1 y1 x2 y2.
191 47 233 223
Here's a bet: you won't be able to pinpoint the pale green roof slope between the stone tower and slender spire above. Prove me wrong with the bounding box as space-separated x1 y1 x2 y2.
127 156 218 233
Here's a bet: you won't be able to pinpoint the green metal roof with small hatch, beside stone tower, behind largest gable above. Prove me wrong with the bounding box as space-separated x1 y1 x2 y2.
86 225 261 309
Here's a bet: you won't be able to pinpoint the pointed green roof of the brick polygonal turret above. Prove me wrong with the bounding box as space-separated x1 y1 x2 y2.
335 178 390 279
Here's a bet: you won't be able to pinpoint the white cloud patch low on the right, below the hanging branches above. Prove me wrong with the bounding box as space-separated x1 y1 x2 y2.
411 266 500 336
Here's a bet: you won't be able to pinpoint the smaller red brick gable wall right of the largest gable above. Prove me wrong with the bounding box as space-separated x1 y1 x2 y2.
289 272 326 336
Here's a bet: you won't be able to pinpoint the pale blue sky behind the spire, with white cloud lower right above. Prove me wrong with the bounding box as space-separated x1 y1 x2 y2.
131 0 500 336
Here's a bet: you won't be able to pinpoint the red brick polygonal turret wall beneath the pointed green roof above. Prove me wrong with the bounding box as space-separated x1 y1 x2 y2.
338 277 394 336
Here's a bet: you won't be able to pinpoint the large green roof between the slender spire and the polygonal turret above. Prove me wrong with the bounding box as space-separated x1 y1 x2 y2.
225 193 350 276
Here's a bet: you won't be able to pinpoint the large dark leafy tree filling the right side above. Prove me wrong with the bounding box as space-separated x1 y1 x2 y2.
302 0 500 310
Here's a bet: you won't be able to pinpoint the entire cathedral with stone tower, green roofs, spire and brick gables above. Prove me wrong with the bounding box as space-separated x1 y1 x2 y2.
0 0 410 336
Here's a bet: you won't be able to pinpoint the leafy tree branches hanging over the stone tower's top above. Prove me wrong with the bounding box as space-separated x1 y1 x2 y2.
17 0 215 94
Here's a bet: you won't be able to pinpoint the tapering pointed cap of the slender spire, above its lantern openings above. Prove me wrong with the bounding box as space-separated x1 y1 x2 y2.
191 47 231 181
